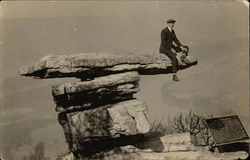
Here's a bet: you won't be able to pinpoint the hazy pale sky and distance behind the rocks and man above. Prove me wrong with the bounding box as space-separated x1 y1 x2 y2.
0 1 249 159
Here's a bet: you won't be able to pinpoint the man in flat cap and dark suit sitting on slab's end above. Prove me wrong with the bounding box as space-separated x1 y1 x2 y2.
160 19 189 81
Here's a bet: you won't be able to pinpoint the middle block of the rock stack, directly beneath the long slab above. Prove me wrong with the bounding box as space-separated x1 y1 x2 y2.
52 72 140 111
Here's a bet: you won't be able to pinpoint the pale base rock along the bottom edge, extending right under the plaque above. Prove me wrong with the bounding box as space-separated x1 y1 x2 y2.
57 133 248 160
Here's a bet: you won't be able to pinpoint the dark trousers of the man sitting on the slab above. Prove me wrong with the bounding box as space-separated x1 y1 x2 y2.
163 46 189 73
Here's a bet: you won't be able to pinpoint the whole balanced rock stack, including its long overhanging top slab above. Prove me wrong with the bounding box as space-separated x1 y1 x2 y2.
19 53 197 157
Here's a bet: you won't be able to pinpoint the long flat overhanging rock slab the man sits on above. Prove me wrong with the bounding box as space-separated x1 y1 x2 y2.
19 53 197 79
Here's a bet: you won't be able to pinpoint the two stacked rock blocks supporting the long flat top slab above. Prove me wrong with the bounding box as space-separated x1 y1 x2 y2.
52 71 150 153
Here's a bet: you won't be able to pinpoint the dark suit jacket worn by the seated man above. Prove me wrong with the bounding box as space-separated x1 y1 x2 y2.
160 27 182 53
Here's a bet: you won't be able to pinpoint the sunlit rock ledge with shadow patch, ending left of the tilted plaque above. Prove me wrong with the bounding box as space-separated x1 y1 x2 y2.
58 133 196 160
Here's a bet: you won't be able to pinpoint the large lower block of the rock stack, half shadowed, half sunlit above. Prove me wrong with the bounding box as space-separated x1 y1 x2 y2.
58 99 150 151
